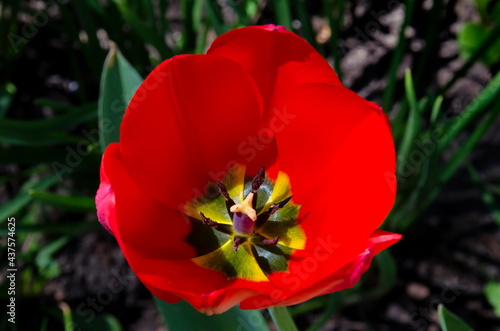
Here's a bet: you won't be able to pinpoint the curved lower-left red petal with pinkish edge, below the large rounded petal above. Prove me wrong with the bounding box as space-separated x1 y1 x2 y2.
103 144 282 314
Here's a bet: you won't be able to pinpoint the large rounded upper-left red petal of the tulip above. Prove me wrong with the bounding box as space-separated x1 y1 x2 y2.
120 55 262 209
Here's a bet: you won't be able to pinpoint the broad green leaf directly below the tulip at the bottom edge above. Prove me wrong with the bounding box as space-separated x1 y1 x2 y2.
154 298 269 331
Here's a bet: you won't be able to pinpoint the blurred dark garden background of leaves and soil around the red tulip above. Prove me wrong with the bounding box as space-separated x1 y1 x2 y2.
0 0 500 330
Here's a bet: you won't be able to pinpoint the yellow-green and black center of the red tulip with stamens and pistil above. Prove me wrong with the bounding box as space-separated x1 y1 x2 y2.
184 165 306 282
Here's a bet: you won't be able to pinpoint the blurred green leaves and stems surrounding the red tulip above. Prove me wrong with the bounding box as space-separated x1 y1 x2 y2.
0 0 500 330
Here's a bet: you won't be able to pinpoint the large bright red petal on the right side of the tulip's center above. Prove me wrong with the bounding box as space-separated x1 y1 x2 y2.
276 84 396 248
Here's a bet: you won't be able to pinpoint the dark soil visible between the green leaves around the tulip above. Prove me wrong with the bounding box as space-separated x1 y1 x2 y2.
0 0 500 331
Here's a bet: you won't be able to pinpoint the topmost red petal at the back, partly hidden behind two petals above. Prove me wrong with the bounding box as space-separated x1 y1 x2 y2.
207 25 341 110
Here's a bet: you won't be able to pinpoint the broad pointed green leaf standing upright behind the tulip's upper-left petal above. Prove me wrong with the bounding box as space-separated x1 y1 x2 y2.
98 44 142 152
